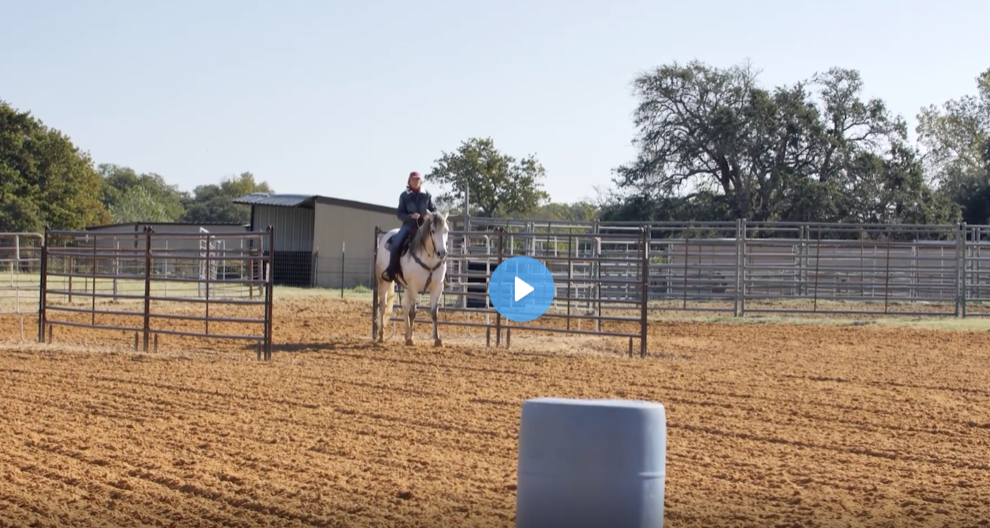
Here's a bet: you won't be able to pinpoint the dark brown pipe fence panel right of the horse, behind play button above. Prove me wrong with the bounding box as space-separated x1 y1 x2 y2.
371 226 649 356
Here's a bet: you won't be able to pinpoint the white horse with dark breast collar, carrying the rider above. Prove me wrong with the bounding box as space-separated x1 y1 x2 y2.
375 213 450 346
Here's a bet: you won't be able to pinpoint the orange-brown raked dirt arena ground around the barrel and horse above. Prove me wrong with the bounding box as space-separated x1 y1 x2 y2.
0 297 990 528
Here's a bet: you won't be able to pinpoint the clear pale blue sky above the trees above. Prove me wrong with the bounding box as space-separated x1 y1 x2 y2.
0 0 990 205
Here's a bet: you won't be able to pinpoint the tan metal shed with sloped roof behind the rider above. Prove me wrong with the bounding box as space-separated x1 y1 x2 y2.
234 193 399 288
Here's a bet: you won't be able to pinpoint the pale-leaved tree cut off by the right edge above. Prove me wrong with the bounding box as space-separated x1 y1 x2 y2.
917 68 990 224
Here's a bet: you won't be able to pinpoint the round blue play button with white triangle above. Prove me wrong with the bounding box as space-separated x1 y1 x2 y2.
488 257 556 323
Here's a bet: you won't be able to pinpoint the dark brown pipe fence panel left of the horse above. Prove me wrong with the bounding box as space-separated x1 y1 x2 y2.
38 227 274 360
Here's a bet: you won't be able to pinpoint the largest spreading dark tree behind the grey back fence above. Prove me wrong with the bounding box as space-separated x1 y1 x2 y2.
614 62 953 222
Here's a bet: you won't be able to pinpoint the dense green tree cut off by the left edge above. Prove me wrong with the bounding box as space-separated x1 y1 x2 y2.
0 100 109 232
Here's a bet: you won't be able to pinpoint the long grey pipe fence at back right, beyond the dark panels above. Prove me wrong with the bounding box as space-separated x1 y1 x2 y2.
444 218 990 317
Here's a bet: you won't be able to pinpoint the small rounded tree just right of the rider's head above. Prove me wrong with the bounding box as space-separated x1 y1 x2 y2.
424 138 550 217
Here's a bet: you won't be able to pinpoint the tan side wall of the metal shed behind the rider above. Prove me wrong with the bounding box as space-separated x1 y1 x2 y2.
314 202 400 288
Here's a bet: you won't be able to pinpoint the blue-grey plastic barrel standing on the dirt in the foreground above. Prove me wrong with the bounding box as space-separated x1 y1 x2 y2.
516 398 667 528
